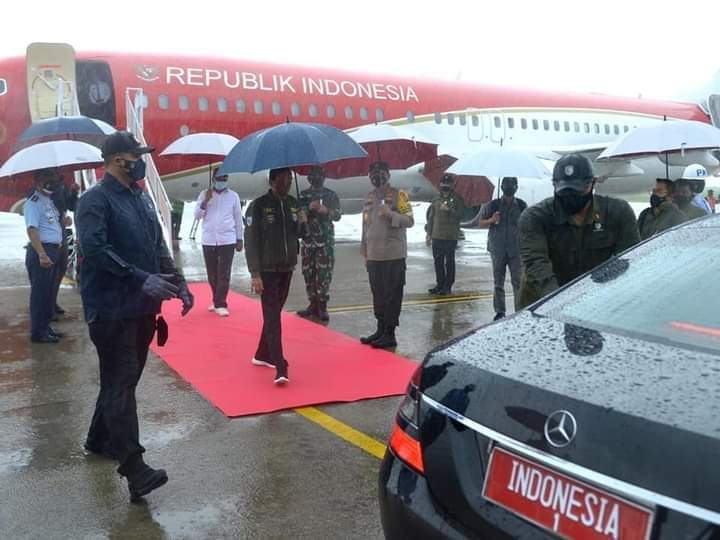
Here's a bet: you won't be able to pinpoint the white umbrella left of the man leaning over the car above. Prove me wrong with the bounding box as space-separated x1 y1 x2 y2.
447 148 550 178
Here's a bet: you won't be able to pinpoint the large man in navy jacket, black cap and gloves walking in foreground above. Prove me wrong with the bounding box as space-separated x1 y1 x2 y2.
75 131 194 500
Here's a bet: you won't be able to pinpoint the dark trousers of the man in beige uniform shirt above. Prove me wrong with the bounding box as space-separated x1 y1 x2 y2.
367 259 406 328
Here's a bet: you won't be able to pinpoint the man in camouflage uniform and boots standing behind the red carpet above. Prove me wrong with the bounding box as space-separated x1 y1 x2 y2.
297 165 342 321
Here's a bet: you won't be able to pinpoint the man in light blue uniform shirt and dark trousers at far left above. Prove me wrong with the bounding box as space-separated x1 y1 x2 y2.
24 169 62 343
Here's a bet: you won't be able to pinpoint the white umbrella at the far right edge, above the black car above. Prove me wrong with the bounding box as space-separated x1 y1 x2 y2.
597 120 720 161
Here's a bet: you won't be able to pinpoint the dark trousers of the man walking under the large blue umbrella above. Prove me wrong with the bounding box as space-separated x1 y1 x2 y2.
255 272 292 367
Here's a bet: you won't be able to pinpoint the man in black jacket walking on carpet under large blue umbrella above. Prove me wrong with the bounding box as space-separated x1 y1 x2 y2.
245 169 307 384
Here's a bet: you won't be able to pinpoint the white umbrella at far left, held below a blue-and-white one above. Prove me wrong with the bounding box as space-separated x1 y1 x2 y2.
0 141 103 177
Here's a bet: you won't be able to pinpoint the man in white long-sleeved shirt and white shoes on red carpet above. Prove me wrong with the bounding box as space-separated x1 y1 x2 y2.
195 175 244 317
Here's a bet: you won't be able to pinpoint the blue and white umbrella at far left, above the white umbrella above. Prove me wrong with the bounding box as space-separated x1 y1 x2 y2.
16 116 115 148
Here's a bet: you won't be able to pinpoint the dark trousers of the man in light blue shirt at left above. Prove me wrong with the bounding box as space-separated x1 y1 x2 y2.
25 244 58 339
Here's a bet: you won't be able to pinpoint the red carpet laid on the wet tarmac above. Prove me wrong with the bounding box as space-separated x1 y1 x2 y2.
152 284 417 416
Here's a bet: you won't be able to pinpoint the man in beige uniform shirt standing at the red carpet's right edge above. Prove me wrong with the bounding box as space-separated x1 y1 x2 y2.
360 161 415 349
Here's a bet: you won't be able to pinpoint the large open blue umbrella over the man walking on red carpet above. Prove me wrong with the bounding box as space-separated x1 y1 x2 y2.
219 122 367 174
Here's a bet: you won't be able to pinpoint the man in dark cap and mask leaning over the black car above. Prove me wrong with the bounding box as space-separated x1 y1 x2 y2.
519 154 640 308
